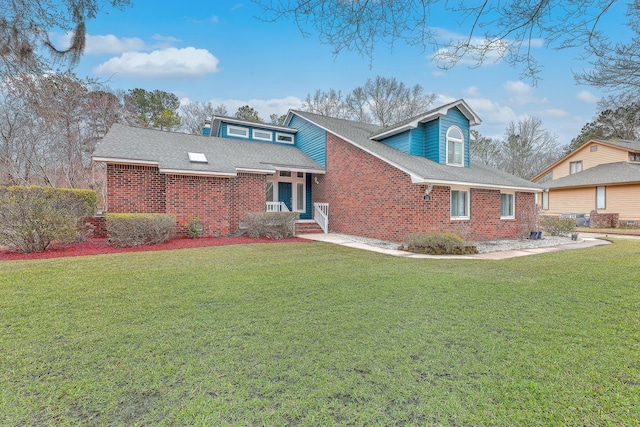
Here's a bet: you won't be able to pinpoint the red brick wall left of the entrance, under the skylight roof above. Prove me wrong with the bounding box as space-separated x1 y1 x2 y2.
107 165 265 237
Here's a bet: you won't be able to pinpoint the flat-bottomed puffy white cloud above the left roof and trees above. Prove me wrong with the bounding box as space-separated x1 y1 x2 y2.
93 47 219 79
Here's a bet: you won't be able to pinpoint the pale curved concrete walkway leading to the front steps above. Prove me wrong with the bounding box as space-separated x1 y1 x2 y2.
297 233 612 260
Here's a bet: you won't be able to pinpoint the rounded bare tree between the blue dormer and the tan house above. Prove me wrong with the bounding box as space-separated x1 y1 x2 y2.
500 117 562 179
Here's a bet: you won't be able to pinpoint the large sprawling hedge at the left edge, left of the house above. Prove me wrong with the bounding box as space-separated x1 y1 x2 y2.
0 186 98 252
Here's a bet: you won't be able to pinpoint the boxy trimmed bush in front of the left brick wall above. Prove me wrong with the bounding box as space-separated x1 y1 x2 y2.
105 213 176 247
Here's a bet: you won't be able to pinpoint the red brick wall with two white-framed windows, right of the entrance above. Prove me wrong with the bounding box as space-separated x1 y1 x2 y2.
313 133 535 241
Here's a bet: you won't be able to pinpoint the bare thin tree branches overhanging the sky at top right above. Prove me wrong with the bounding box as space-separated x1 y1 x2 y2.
253 0 640 87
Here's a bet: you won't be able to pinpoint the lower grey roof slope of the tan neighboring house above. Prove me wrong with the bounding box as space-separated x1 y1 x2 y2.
541 162 640 188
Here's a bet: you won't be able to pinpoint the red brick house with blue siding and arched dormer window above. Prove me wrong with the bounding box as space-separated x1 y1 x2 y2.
93 100 540 241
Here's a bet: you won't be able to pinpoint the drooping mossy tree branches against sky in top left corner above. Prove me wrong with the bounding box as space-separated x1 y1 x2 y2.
0 0 129 76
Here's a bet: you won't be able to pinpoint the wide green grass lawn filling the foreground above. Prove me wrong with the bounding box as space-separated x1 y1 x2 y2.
0 240 640 426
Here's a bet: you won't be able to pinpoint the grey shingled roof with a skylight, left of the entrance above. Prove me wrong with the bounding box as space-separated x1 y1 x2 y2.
93 124 324 176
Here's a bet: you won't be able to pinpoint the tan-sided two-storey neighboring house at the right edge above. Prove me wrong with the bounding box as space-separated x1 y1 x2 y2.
533 140 640 225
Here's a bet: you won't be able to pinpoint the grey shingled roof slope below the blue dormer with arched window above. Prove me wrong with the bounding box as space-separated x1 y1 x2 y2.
290 111 541 191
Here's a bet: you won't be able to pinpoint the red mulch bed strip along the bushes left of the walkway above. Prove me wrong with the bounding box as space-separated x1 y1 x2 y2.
0 236 310 261
